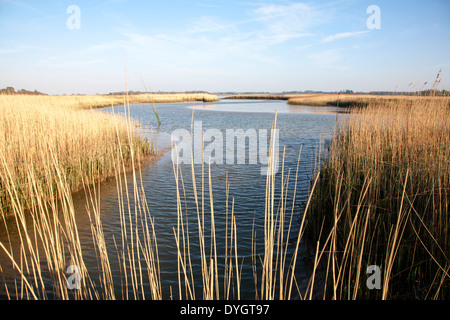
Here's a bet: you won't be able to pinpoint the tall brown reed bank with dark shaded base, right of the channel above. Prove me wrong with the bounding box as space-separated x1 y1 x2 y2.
306 98 450 299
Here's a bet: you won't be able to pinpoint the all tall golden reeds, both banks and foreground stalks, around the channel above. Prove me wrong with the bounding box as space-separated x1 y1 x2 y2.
0 92 450 300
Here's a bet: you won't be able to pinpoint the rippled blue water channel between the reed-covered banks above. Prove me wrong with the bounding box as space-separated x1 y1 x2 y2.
0 99 345 299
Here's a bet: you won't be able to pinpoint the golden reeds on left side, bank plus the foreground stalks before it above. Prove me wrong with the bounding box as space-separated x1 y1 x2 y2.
0 95 160 299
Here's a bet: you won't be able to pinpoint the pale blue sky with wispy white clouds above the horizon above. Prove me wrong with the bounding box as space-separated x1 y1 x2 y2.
0 0 450 94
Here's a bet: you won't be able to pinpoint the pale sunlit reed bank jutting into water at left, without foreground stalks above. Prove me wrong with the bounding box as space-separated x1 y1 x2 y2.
0 95 155 215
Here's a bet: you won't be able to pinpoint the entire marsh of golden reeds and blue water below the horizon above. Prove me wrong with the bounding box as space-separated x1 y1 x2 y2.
0 90 450 299
